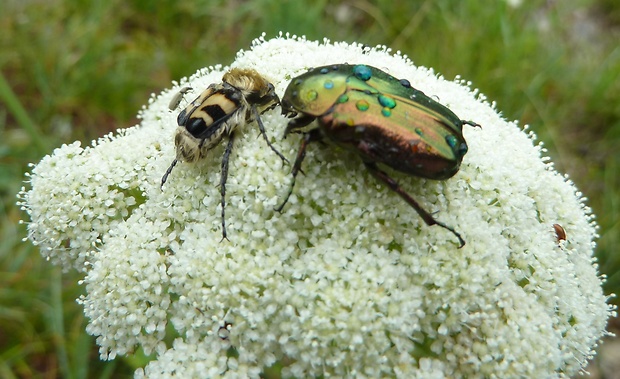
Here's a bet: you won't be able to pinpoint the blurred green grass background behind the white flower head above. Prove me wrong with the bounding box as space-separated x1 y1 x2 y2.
0 0 620 378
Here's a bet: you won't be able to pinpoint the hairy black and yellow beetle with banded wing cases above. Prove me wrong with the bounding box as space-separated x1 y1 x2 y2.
161 68 288 239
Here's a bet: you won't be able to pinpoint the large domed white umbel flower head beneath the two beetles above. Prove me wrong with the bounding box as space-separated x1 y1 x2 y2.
20 35 613 378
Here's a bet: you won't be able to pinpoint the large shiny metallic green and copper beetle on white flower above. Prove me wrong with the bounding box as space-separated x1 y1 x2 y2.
276 64 480 247
